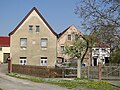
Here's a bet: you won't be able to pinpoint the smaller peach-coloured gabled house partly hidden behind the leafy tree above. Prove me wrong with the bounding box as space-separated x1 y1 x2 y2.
57 25 90 65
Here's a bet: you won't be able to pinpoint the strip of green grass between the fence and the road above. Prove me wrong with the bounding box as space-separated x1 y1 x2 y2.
8 73 120 90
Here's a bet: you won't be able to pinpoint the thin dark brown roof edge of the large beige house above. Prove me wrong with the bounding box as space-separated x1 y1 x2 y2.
9 7 57 36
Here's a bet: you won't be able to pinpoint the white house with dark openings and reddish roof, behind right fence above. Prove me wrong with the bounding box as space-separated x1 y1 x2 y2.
92 41 110 66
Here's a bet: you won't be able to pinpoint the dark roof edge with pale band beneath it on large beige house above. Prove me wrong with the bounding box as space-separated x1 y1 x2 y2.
9 7 57 36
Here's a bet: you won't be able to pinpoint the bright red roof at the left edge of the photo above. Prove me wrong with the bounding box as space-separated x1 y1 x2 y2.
0 36 10 47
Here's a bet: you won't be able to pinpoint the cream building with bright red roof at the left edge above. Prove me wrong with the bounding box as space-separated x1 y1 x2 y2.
0 36 10 63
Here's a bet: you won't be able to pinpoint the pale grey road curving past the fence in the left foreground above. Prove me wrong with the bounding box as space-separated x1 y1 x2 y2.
0 64 68 90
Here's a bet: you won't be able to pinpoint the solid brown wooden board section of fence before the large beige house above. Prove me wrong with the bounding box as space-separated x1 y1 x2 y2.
12 64 62 78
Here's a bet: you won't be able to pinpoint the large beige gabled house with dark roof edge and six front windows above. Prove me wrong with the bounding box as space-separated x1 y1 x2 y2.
9 7 57 67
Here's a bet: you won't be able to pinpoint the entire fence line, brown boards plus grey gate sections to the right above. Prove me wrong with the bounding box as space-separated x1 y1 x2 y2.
12 64 120 79
